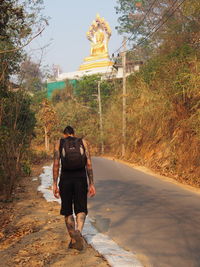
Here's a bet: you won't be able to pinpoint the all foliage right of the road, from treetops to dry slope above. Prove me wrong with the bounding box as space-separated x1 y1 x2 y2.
101 0 200 186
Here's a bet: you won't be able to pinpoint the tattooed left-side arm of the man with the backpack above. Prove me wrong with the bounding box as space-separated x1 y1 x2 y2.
53 142 60 198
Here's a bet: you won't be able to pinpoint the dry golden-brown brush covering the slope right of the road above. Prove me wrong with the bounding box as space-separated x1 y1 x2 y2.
105 45 200 186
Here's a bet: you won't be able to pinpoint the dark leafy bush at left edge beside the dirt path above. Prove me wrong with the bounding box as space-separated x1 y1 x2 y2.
0 91 35 197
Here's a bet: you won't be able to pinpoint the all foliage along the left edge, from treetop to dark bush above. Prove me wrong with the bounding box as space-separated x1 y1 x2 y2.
0 0 46 197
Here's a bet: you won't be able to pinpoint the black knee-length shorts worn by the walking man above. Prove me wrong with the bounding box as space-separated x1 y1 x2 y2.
59 177 88 216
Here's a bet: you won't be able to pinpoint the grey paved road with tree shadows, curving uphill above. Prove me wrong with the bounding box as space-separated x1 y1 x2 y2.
89 157 200 267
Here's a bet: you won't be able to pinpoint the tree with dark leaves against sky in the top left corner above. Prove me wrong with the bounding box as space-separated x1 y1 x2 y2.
0 0 47 90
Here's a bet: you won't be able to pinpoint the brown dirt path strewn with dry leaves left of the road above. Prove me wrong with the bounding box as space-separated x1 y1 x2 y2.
0 166 109 267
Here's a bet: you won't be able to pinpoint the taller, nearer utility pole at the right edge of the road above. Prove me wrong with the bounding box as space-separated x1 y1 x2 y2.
122 37 126 157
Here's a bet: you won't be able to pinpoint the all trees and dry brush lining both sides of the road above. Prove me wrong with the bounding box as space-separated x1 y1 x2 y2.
0 0 200 201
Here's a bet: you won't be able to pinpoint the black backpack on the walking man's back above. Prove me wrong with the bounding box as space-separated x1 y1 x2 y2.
60 136 87 170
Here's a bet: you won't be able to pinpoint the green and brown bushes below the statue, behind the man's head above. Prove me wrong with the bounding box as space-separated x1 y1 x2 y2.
48 75 114 151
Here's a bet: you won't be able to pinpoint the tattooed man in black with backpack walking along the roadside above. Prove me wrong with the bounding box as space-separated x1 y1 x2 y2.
53 126 96 250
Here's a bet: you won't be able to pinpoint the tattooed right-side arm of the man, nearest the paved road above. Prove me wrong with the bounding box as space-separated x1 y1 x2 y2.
83 139 96 196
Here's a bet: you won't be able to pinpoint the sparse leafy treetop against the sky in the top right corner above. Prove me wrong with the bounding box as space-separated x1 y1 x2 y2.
116 0 200 54
